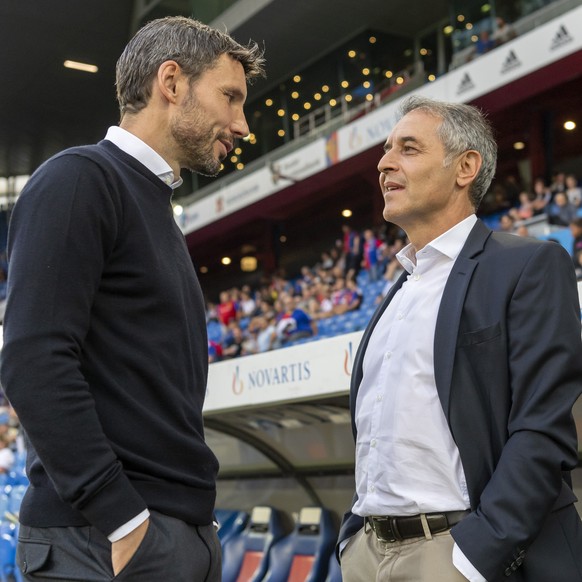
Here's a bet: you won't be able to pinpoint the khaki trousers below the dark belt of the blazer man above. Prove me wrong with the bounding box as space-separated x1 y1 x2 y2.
341 524 467 582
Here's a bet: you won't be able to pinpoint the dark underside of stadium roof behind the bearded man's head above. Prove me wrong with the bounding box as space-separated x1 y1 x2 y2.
0 0 449 177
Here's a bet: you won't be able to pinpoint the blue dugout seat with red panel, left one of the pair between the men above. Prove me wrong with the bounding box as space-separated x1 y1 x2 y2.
222 506 290 582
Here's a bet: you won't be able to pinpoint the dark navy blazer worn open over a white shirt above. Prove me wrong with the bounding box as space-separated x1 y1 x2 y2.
339 221 582 582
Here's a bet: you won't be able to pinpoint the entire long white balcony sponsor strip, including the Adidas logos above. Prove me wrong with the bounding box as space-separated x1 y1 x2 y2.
177 6 582 234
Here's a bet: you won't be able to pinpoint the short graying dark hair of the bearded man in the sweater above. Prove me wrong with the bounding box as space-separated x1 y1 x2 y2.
116 16 265 117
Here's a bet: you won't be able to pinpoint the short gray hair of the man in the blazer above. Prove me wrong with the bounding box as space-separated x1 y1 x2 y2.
399 95 497 209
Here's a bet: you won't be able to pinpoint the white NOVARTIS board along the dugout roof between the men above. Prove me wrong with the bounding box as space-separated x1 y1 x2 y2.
204 332 362 413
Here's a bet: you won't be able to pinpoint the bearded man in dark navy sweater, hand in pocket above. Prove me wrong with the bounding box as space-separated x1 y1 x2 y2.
1 17 263 582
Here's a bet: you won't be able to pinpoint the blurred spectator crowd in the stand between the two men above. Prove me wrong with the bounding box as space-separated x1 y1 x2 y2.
207 225 406 362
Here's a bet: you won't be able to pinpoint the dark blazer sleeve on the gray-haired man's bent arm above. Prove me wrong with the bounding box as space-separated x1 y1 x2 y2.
452 243 582 580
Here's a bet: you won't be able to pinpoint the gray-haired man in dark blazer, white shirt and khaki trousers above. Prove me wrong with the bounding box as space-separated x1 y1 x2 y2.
338 97 582 582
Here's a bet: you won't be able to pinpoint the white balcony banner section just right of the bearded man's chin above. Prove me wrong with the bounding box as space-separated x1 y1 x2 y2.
177 138 329 234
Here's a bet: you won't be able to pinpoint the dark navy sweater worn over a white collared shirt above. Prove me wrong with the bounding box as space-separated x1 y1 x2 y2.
0 141 218 535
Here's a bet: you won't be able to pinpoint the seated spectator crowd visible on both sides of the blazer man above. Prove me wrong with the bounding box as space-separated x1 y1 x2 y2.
207 172 582 362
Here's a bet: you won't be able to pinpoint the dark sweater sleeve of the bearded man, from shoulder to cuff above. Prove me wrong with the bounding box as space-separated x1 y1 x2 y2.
1 154 146 535
